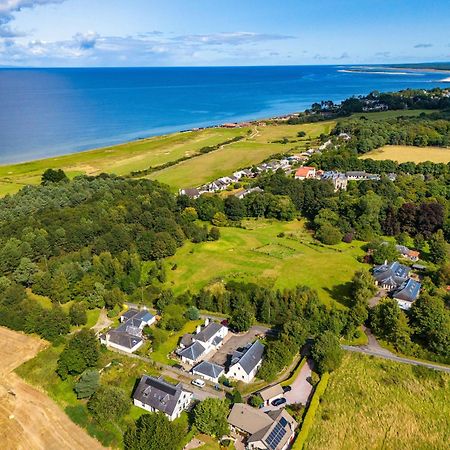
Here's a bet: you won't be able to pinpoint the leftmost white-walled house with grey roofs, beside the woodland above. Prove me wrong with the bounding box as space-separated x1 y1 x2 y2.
100 309 156 353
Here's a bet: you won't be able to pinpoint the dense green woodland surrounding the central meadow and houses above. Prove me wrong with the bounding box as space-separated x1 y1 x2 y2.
0 90 450 449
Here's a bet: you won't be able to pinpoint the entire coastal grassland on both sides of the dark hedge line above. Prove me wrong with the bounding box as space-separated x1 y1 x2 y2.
0 122 333 196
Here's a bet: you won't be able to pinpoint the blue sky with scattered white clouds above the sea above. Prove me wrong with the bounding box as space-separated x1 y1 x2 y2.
0 0 450 67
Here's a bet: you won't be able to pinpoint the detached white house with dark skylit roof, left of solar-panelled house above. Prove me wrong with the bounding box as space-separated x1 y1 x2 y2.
133 375 193 420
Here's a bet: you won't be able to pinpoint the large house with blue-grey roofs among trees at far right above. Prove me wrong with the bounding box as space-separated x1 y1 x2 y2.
373 261 421 310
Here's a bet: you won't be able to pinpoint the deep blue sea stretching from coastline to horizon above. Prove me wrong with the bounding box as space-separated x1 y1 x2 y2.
0 66 448 164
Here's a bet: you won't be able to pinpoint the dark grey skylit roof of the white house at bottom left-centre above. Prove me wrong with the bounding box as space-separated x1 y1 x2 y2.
133 375 187 416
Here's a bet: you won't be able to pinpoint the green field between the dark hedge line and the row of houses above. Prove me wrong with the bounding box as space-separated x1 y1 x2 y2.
148 122 334 188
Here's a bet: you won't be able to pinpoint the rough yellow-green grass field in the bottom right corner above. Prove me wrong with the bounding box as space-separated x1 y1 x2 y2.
304 353 450 450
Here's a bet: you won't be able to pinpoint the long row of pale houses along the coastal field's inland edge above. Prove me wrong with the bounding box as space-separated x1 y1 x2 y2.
179 155 306 199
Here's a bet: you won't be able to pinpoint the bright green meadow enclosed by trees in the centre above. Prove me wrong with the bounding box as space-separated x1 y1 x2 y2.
166 220 364 304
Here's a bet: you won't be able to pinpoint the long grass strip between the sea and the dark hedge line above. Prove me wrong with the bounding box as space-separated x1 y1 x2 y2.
0 128 248 195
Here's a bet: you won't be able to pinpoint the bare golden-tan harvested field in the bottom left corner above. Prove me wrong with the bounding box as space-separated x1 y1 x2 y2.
0 327 103 450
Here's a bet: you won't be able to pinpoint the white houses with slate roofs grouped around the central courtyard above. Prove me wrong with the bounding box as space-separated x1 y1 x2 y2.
176 319 264 383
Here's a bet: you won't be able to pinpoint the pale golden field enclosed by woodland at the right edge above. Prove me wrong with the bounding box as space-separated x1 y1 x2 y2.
361 145 450 163
